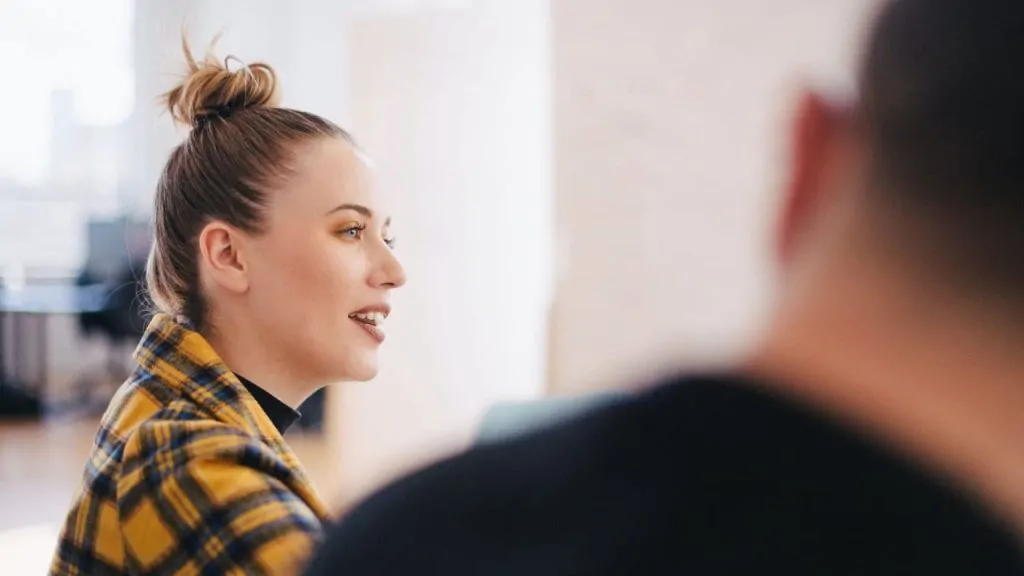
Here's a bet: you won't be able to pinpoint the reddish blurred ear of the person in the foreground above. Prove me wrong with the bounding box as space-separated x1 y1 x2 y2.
774 90 848 266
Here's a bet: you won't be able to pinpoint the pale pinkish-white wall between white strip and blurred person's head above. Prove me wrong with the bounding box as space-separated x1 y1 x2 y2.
552 0 874 393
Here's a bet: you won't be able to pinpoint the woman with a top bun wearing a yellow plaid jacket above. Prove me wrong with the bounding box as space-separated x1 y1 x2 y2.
51 38 406 574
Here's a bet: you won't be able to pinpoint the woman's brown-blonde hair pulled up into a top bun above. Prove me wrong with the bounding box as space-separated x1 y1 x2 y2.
146 41 352 329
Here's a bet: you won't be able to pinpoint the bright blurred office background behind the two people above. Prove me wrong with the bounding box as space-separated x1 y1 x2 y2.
0 0 877 574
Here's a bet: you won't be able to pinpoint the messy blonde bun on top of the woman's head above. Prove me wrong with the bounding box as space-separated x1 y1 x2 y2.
164 37 278 127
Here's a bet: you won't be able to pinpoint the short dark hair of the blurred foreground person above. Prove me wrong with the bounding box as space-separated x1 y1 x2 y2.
859 0 1024 303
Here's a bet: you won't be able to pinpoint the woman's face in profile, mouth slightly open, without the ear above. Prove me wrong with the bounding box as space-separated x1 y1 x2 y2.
241 138 406 383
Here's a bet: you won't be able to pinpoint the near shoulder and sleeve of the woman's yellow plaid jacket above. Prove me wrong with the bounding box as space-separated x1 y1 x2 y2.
110 417 322 573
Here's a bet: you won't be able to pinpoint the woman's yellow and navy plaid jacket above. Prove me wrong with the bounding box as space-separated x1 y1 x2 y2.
50 316 328 576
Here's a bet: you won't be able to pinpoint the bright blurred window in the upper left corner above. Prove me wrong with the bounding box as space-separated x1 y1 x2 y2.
0 0 136 276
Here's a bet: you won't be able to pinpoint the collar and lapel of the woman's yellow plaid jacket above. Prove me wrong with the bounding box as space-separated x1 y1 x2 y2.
134 314 328 518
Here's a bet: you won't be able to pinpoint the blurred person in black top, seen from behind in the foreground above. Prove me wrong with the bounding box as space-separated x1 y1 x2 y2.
308 0 1024 576
